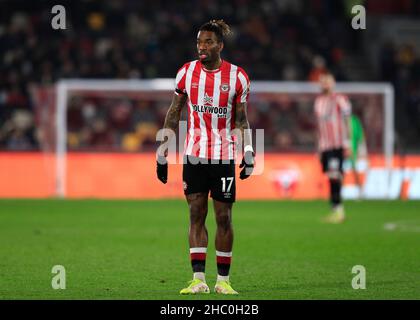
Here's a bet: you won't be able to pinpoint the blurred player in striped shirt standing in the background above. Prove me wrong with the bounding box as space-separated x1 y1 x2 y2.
314 72 351 223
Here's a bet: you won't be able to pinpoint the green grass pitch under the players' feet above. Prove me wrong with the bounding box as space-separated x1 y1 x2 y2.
0 200 420 300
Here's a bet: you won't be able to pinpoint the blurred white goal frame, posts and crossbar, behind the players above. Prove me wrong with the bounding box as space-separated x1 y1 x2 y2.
49 78 394 197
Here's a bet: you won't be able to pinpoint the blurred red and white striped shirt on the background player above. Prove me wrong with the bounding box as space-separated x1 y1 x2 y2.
315 93 351 151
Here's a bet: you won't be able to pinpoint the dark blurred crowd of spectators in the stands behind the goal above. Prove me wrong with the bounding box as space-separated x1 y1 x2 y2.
0 0 420 151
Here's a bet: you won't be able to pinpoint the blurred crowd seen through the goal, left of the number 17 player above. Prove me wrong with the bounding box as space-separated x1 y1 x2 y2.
67 97 169 151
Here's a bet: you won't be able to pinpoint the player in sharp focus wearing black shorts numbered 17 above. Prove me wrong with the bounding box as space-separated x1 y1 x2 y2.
157 20 254 294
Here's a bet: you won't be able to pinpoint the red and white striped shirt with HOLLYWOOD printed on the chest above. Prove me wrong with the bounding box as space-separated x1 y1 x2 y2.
175 60 250 160
